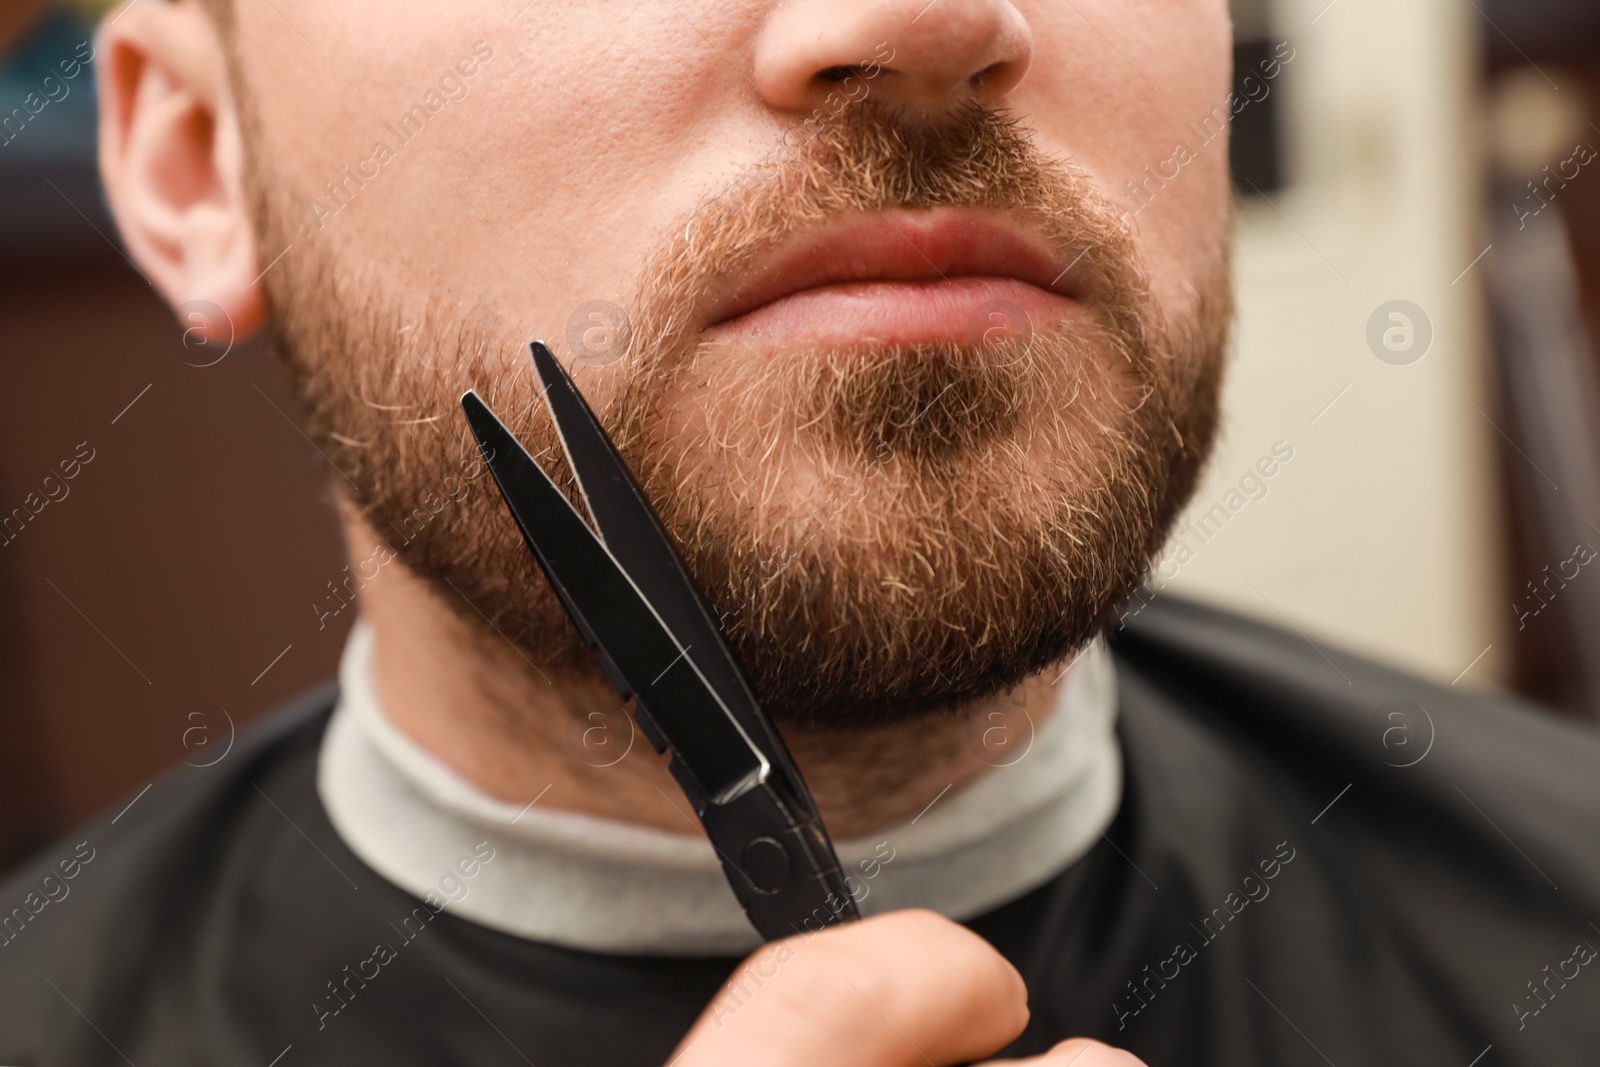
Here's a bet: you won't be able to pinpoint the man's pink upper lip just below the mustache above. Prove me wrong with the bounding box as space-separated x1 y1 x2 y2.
707 208 1080 326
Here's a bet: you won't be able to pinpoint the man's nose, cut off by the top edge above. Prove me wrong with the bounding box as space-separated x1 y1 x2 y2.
755 0 1034 114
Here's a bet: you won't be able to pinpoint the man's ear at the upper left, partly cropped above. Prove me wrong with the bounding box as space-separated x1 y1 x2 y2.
98 0 266 342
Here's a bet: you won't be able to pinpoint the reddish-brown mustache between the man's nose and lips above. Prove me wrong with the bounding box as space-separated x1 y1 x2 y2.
602 98 1160 456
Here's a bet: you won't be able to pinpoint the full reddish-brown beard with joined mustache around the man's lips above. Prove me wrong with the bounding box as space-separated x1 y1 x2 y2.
246 106 1230 729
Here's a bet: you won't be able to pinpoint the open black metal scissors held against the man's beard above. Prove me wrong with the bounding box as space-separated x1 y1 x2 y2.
461 342 861 941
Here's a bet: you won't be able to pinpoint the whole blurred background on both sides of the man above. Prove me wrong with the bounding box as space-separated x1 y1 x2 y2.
0 0 1600 869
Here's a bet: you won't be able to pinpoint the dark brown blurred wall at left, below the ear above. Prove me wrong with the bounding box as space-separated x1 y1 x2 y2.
0 254 350 865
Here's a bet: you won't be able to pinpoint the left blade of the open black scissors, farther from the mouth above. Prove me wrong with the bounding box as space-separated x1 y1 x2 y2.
461 392 770 803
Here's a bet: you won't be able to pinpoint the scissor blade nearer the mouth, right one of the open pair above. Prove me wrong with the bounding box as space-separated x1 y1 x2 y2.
530 342 814 799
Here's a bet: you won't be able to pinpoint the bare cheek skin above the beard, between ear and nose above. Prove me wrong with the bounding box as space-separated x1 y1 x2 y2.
240 0 776 351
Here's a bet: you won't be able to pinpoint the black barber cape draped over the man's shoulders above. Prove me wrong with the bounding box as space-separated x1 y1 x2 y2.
0 597 1600 1067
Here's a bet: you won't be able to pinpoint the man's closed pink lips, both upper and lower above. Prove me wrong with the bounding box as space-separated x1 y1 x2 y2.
704 208 1082 350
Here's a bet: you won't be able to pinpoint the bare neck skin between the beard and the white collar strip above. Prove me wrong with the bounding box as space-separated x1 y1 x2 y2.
344 509 1056 838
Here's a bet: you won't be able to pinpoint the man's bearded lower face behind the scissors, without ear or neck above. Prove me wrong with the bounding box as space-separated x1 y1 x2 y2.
232 0 1229 725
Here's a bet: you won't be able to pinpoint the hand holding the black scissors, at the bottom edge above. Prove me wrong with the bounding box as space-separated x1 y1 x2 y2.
667 910 1142 1067
